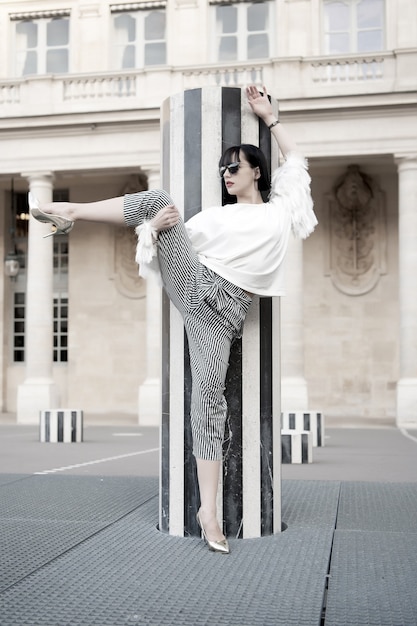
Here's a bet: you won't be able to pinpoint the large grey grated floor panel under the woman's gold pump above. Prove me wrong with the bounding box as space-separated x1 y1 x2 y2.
0 492 333 626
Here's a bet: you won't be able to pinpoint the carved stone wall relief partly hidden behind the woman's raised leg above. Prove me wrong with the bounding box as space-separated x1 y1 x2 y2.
114 172 148 298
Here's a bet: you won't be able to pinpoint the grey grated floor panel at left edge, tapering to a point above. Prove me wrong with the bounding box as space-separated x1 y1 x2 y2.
0 475 158 592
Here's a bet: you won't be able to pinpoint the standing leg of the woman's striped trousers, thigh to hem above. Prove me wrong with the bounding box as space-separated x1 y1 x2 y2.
184 302 235 461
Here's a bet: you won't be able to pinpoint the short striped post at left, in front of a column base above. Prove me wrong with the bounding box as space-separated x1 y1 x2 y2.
40 409 83 443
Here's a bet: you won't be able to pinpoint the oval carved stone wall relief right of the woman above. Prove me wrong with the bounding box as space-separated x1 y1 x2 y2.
326 165 386 296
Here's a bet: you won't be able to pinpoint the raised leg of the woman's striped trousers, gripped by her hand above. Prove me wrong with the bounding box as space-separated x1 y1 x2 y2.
124 189 202 314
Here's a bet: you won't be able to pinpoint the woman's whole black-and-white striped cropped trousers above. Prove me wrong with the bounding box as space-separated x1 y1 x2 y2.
124 190 251 461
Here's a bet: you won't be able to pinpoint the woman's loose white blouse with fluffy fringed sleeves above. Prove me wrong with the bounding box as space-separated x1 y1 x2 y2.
136 153 317 296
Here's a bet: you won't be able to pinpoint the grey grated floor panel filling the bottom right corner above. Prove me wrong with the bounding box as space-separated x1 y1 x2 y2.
325 530 417 626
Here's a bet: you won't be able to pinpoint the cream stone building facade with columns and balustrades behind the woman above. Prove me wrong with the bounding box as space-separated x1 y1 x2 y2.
0 0 417 426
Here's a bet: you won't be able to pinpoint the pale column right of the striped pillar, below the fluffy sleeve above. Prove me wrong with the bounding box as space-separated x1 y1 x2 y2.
281 236 308 411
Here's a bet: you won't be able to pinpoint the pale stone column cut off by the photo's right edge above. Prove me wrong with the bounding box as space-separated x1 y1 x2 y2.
397 154 417 428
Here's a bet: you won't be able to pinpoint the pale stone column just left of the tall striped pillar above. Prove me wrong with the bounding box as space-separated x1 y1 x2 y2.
138 170 162 426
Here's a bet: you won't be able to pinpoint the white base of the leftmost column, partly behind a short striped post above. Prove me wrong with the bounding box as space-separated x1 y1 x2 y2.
16 379 59 424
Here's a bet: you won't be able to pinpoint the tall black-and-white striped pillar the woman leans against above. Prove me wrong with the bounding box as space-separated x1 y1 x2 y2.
159 87 281 538
